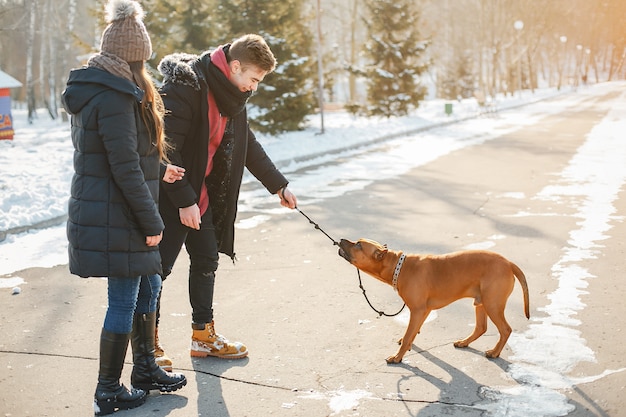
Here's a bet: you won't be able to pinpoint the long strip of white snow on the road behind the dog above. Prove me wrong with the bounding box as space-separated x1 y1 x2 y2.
472 83 626 417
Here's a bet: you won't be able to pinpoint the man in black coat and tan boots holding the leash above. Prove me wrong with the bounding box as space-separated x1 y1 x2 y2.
156 35 297 369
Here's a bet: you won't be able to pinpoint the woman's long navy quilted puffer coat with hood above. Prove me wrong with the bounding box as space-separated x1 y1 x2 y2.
63 67 164 277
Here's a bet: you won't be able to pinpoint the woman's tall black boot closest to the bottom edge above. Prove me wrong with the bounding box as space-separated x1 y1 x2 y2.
93 329 146 416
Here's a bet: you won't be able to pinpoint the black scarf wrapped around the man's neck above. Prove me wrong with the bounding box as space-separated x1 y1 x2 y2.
200 45 252 118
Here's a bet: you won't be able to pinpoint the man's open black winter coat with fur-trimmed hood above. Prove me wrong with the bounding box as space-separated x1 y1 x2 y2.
159 54 288 258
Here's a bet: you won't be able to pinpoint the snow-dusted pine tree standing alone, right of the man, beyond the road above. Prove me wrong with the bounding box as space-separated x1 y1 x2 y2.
364 0 429 117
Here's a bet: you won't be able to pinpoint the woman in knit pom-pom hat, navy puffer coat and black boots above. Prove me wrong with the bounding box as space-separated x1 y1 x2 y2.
63 0 187 415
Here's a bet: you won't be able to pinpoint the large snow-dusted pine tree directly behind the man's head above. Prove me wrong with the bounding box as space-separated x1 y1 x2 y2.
217 0 316 134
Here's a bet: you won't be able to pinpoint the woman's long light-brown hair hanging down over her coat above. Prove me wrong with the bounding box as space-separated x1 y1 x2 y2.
129 61 169 162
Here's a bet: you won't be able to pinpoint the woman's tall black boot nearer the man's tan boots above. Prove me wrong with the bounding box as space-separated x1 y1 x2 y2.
130 312 187 392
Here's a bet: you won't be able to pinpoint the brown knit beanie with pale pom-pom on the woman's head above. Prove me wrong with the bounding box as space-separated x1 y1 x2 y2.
100 0 152 62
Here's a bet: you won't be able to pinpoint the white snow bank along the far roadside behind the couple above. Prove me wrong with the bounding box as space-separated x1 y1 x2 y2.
0 90 560 275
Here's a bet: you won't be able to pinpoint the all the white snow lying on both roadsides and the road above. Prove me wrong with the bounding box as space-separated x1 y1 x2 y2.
0 82 626 417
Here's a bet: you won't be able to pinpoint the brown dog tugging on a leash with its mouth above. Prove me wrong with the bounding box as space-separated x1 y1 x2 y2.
339 239 530 363
